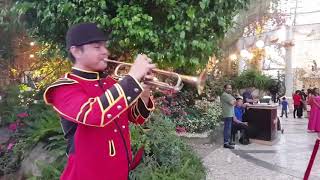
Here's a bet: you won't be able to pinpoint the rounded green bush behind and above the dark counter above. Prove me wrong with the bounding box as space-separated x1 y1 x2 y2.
233 70 274 90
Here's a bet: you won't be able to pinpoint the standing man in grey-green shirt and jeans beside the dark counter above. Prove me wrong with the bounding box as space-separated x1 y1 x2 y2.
221 84 236 149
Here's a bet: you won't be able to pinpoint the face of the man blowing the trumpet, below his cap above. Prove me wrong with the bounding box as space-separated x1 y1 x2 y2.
73 41 110 71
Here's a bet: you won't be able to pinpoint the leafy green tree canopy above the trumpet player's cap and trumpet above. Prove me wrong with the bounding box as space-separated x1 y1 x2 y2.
5 0 249 72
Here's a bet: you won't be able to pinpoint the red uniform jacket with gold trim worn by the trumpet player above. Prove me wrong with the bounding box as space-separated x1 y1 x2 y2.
44 68 154 180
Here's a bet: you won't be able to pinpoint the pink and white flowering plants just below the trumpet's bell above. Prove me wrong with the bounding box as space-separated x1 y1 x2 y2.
155 91 221 133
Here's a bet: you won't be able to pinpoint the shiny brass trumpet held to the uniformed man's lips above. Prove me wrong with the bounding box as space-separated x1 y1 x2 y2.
105 59 207 94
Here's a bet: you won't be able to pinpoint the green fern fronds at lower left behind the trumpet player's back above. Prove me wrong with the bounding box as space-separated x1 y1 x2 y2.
0 103 66 179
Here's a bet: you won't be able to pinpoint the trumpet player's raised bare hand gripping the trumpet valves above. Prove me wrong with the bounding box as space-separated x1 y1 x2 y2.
128 54 156 81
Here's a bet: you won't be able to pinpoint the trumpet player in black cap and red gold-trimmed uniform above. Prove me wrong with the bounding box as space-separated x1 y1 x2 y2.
44 23 155 180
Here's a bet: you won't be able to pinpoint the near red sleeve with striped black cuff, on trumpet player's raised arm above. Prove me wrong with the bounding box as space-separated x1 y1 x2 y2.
44 76 142 127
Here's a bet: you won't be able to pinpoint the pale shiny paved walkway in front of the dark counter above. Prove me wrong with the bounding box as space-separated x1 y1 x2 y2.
197 109 320 180
